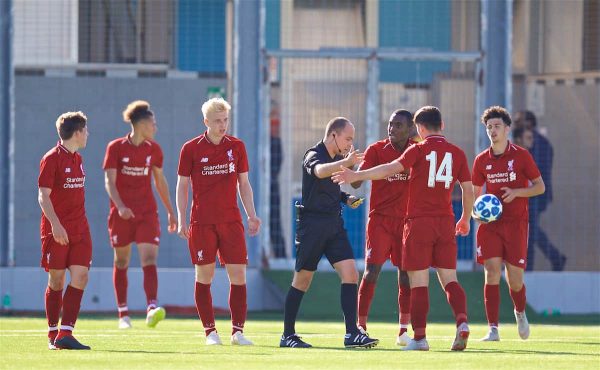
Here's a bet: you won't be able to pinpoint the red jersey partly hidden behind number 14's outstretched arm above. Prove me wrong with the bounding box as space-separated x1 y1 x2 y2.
358 138 415 217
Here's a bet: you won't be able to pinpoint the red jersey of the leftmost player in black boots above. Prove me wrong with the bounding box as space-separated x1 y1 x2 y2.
38 143 88 237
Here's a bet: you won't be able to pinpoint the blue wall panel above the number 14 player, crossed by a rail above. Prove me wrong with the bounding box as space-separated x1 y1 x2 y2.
379 0 451 84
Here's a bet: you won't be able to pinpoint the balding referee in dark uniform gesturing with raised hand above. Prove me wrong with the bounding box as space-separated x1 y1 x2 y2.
279 117 379 348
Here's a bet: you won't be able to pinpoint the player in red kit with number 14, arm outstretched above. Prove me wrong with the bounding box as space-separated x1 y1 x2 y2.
334 106 473 351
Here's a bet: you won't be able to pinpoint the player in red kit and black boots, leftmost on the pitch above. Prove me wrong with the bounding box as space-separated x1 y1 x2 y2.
38 112 92 349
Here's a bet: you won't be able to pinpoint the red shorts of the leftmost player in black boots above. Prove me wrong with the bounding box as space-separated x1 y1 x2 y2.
40 229 92 271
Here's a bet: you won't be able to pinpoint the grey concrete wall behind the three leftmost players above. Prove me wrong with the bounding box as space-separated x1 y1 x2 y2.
10 69 226 267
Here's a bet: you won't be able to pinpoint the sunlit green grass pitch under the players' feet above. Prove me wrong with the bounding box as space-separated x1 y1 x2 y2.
0 313 600 370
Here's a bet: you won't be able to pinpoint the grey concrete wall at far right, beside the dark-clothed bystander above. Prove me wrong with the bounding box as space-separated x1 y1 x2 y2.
515 72 600 271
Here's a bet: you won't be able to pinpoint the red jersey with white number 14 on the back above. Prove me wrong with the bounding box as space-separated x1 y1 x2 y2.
397 135 471 218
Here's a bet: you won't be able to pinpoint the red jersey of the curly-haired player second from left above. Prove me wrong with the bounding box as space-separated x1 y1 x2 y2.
102 135 163 215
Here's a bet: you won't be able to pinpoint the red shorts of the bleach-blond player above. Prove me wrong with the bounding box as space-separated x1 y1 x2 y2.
188 221 248 265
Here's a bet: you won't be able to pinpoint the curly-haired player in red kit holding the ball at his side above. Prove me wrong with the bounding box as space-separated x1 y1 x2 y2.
473 106 545 341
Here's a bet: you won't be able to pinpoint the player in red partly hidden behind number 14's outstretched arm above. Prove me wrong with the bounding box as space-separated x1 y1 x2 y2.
351 109 415 346
